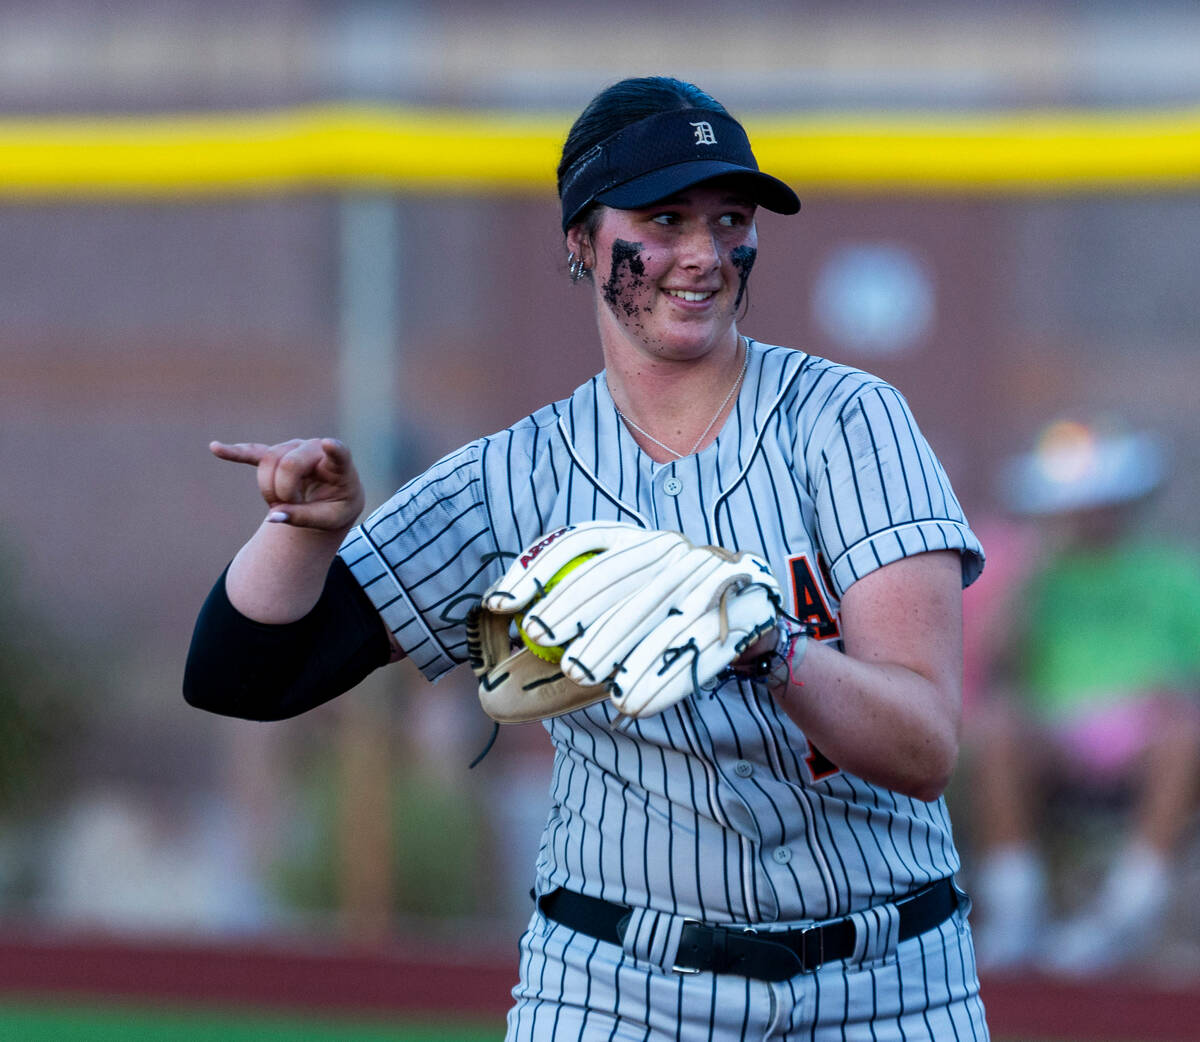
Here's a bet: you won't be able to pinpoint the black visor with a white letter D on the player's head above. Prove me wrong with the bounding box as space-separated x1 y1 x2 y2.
562 108 800 233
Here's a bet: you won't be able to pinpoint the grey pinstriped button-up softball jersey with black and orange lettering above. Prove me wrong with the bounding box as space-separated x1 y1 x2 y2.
341 341 983 923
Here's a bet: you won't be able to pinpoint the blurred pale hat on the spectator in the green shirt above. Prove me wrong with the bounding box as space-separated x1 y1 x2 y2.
1001 420 1166 515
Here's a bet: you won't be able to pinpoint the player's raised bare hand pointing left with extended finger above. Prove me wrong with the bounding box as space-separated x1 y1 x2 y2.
209 438 365 534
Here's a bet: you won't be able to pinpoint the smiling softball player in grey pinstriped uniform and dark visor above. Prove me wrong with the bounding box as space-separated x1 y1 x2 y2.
185 78 988 1042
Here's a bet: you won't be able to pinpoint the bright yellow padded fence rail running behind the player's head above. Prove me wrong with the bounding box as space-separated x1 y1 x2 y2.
0 104 1200 202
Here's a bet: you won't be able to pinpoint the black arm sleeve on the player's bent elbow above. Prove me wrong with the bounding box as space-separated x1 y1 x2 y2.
184 557 391 720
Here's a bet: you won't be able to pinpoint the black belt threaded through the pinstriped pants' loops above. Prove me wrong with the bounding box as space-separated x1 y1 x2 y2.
538 879 959 981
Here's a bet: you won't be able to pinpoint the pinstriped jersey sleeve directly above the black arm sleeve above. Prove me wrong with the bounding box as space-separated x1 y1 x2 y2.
338 443 496 681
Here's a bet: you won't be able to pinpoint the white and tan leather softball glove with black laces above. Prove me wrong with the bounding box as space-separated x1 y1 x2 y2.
468 521 781 723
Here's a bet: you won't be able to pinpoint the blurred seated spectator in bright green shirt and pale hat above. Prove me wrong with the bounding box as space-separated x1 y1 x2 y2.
966 421 1200 974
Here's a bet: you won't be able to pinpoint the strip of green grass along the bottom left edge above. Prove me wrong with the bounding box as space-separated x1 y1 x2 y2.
0 1001 504 1042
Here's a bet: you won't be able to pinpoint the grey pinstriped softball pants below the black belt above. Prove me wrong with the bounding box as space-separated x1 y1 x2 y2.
505 909 989 1042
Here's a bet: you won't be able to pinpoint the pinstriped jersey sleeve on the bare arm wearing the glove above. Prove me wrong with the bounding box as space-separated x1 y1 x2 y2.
809 383 984 597
